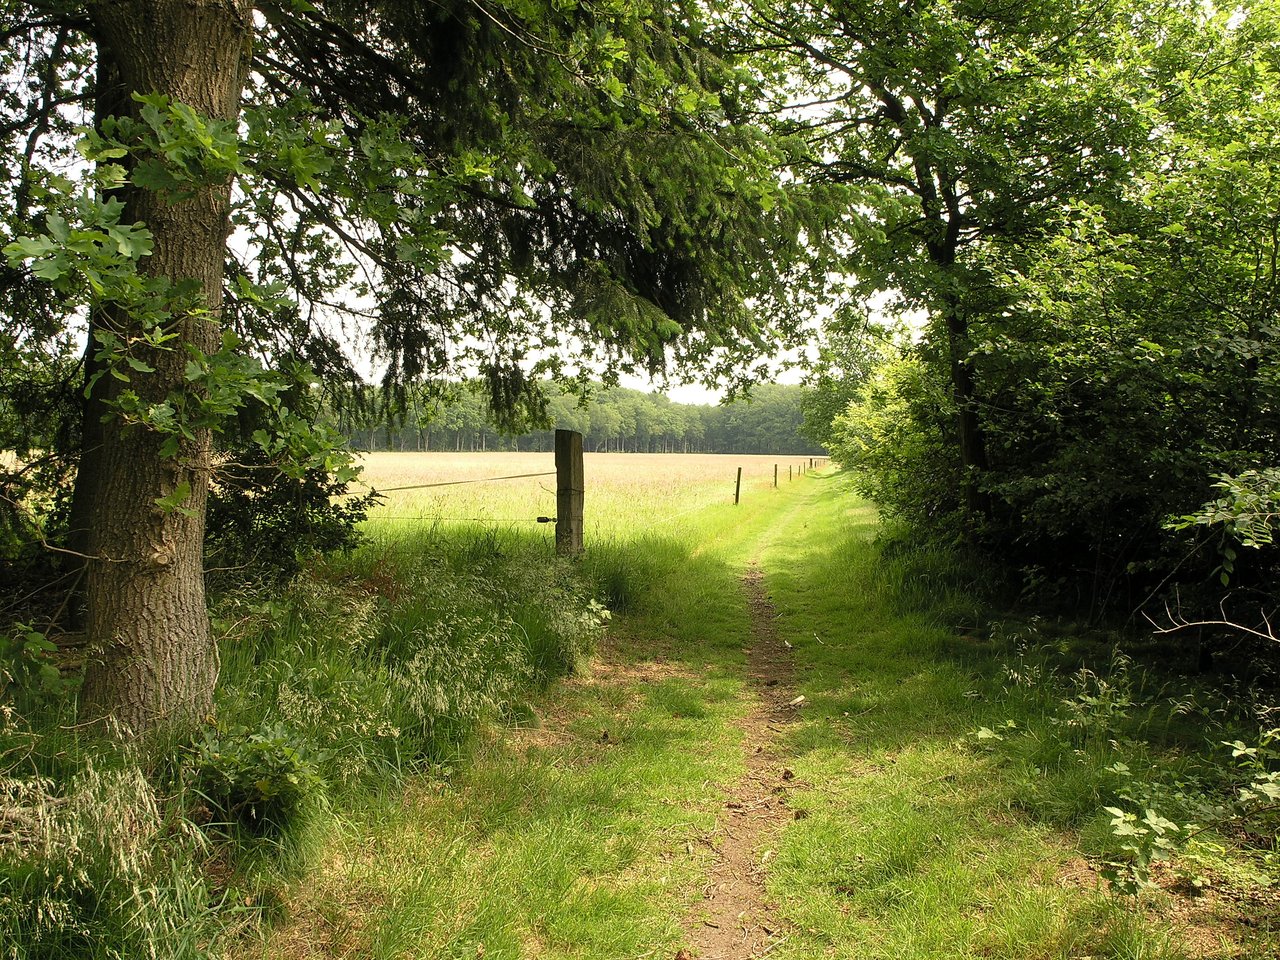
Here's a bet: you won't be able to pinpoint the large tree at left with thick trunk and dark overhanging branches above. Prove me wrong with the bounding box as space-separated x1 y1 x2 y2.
0 0 814 730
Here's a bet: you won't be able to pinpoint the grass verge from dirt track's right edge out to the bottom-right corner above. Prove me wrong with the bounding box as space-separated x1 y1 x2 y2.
764 475 1276 960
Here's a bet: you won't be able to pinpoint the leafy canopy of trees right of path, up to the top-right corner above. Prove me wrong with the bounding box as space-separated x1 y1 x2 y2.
808 4 1280 616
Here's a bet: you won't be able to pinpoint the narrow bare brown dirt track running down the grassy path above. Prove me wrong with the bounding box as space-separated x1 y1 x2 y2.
676 564 800 960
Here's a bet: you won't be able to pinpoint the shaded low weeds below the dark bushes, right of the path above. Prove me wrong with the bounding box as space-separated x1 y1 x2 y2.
878 544 1280 899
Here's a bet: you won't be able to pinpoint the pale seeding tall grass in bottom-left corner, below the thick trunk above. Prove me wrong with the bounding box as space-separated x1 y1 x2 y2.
0 717 210 960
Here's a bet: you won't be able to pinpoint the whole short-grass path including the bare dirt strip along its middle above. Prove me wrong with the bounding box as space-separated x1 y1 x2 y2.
242 475 1180 960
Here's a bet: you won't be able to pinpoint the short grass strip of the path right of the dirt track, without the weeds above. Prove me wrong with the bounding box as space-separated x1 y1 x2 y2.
747 479 1166 960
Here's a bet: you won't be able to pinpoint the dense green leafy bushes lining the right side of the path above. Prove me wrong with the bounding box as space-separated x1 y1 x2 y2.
814 20 1280 624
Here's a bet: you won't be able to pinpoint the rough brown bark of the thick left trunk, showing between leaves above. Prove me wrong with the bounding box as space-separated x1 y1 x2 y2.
81 0 252 732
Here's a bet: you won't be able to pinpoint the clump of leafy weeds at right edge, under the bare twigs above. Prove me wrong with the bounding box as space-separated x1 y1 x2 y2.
970 625 1280 896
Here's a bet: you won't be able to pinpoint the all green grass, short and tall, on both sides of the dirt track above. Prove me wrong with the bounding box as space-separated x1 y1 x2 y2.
0 463 1275 960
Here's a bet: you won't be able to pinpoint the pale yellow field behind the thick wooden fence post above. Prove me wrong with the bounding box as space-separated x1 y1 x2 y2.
362 453 809 539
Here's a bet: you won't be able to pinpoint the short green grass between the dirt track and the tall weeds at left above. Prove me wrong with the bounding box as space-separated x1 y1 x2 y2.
232 478 808 960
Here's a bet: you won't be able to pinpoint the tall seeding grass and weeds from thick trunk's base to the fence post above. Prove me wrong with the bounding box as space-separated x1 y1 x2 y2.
0 530 608 960
